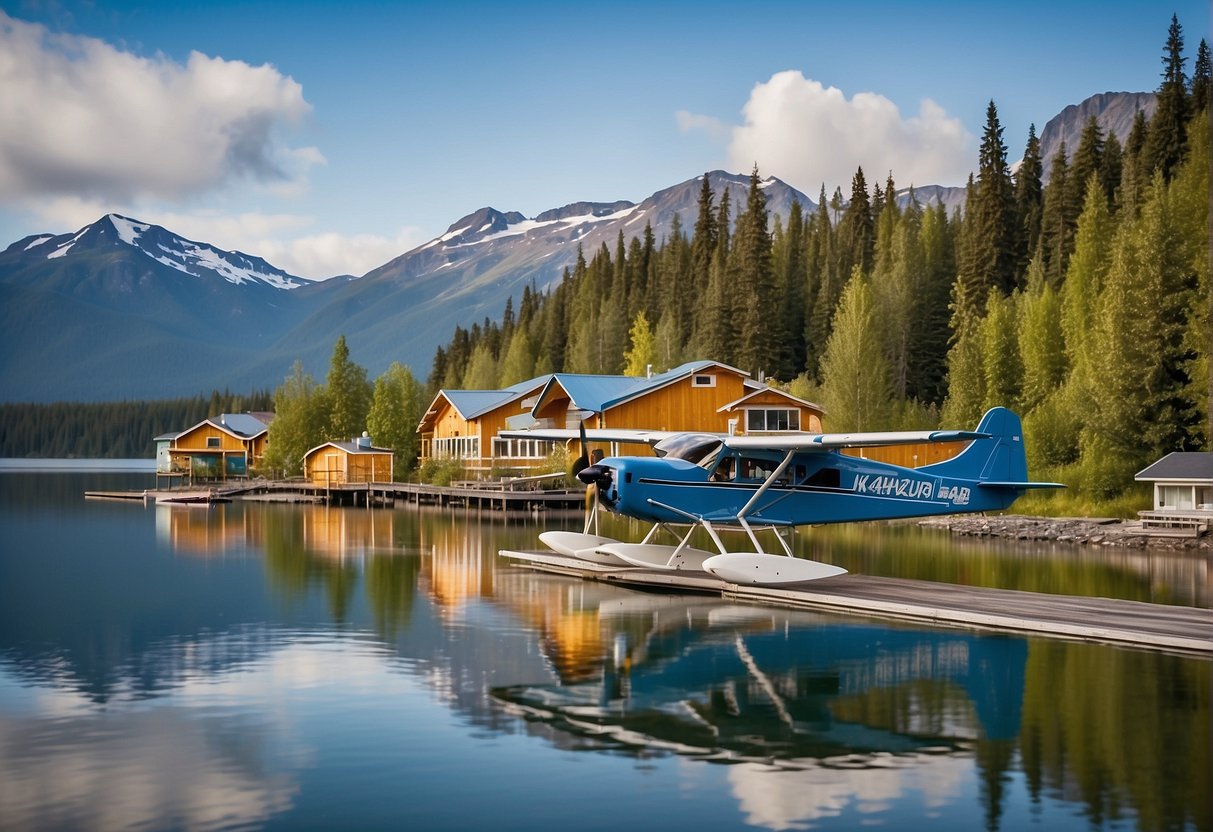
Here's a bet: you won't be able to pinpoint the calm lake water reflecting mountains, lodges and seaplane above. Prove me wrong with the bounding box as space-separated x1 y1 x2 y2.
0 473 1213 831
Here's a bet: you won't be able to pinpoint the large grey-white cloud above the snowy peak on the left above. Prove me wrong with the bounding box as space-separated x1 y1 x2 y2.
0 11 323 204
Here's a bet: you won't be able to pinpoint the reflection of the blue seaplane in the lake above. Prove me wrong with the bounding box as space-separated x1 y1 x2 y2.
492 606 1027 768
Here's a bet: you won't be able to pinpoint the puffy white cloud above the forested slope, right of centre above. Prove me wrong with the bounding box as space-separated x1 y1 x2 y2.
676 70 975 196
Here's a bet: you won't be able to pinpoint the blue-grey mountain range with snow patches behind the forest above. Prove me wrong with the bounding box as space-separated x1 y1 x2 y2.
0 93 1150 401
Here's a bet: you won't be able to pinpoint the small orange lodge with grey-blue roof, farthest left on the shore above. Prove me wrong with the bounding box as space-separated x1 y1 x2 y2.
154 412 274 480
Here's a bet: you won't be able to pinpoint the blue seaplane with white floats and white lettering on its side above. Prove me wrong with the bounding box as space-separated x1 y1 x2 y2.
501 408 1063 586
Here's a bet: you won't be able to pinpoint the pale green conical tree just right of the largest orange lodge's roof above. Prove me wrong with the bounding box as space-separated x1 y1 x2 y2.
821 270 893 431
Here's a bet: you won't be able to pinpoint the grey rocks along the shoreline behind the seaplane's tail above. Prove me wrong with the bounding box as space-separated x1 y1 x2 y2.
918 514 1213 553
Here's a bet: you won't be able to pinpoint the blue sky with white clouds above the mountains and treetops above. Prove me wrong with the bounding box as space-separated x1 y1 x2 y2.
0 0 1209 278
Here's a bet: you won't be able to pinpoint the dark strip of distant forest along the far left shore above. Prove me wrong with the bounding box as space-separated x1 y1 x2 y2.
0 391 273 460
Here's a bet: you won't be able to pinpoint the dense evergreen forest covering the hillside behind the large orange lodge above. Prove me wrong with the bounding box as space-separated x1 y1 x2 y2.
429 17 1211 509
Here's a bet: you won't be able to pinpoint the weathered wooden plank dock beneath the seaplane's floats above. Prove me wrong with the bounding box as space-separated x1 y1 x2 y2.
499 549 1213 657
